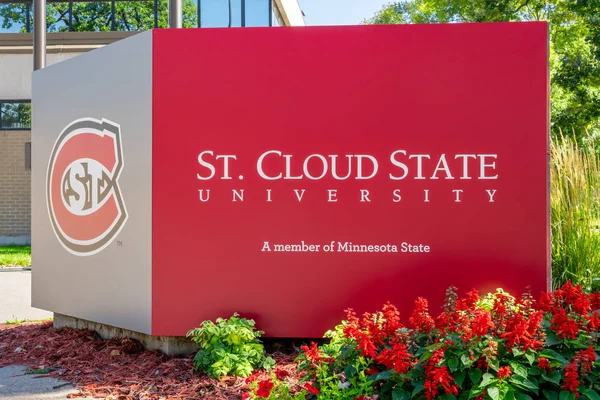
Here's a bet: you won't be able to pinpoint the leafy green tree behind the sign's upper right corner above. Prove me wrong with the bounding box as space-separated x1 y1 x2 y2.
365 0 600 141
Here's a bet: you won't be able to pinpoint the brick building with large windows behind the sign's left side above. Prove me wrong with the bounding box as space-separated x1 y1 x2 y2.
0 0 304 246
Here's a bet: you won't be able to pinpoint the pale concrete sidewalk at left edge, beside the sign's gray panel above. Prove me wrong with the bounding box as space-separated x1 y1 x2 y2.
0 268 53 324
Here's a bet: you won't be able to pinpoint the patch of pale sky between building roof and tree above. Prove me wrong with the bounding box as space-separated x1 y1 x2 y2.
298 0 392 25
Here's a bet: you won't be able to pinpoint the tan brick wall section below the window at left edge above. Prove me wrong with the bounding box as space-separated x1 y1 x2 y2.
0 131 31 244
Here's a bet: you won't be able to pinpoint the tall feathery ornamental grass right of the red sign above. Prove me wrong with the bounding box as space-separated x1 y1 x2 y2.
550 134 600 290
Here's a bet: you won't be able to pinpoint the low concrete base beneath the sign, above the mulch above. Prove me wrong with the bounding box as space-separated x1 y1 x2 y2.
54 313 200 356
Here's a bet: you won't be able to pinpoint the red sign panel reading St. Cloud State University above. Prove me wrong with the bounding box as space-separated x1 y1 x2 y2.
152 23 550 337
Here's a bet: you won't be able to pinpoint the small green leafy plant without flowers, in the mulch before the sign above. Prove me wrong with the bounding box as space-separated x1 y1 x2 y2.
187 313 275 378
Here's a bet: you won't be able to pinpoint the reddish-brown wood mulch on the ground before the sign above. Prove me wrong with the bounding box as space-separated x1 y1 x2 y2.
0 322 301 400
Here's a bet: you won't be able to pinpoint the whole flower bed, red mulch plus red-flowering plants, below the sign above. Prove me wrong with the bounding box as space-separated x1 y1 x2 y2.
0 283 600 400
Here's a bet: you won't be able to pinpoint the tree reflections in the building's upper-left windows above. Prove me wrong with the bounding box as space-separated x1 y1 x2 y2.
0 0 198 32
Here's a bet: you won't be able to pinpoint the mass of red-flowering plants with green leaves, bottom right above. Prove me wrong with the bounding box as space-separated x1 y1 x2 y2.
290 283 600 400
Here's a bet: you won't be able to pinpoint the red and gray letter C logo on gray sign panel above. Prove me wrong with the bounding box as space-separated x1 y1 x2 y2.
46 118 127 256
